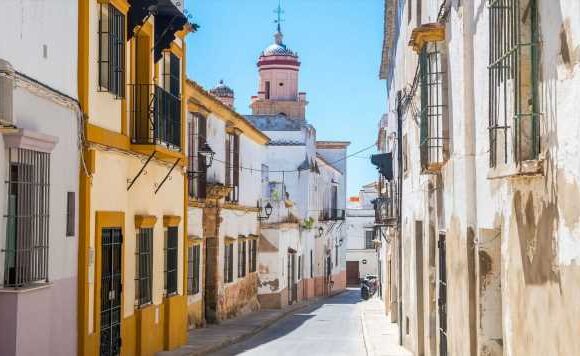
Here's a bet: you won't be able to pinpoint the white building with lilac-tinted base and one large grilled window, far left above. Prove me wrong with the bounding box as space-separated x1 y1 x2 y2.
0 1 82 355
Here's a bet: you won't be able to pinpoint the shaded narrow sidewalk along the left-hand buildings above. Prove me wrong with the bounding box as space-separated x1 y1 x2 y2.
156 297 323 356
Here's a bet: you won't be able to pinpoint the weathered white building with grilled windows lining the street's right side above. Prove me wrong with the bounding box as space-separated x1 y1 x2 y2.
381 0 580 356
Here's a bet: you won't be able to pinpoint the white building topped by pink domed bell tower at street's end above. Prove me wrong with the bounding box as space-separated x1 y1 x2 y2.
246 23 349 308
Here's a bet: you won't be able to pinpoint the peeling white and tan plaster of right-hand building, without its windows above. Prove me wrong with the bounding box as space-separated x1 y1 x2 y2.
388 0 580 356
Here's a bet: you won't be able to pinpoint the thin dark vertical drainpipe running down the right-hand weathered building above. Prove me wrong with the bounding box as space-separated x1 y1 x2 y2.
397 90 403 345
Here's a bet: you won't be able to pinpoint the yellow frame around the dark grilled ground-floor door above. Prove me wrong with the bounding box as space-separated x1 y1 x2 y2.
93 211 125 354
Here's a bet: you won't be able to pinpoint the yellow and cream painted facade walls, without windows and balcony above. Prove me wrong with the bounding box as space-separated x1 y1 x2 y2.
78 0 188 356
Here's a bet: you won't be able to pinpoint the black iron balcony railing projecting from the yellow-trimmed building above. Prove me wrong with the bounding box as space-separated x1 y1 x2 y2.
129 84 181 151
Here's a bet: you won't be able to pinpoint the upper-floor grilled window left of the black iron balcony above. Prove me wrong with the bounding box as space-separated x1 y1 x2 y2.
99 4 125 98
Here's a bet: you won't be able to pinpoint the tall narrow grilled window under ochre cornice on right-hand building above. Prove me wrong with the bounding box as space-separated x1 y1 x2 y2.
419 42 449 172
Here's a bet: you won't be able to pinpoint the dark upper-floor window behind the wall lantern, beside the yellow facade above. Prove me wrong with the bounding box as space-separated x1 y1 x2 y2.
187 113 207 199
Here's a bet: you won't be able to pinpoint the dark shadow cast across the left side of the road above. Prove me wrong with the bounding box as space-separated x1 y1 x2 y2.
211 288 364 356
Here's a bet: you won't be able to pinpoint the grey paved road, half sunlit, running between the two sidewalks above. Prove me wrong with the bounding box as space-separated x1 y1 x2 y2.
212 289 367 356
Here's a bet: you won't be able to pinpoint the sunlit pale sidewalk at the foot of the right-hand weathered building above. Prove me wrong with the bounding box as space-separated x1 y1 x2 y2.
361 297 413 356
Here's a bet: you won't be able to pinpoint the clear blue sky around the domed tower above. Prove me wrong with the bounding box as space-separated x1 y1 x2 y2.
185 0 386 195
